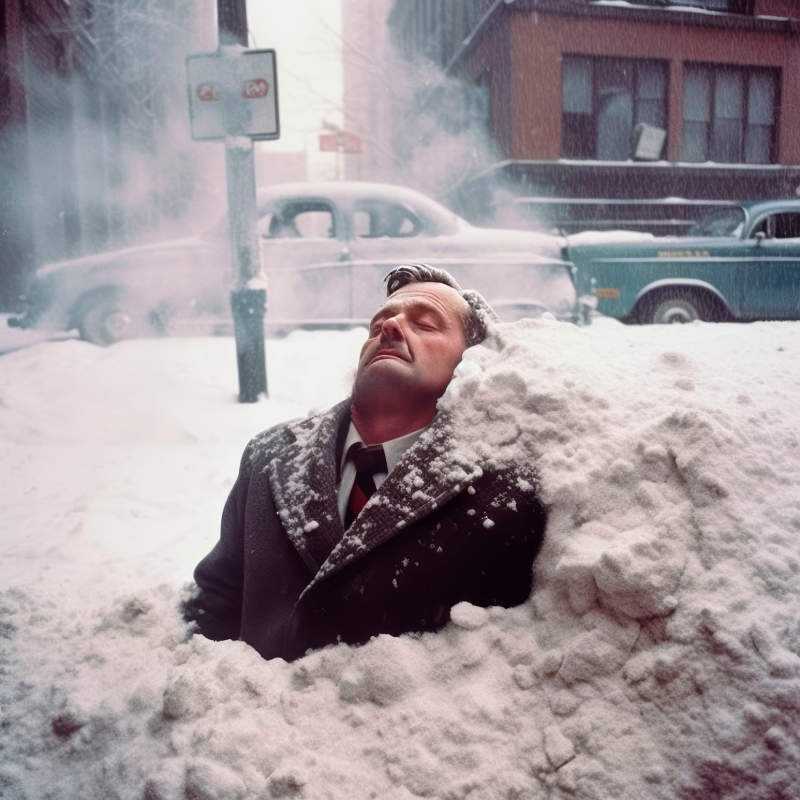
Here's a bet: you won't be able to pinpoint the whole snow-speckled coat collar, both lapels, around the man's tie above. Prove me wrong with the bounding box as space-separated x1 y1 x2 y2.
268 400 483 598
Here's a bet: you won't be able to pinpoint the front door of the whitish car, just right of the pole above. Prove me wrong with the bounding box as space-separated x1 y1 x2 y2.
259 197 350 327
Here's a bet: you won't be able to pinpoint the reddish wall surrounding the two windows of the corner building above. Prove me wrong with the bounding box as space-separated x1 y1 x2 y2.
506 11 800 164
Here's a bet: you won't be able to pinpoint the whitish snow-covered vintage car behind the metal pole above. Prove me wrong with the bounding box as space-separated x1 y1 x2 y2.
10 182 578 344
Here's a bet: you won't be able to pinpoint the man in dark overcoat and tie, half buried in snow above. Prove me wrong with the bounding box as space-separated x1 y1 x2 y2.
184 264 545 660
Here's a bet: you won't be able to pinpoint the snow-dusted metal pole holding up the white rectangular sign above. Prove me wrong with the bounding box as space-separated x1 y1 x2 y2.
217 0 267 403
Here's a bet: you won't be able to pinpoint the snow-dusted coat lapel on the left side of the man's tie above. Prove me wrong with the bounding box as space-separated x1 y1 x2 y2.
267 399 350 574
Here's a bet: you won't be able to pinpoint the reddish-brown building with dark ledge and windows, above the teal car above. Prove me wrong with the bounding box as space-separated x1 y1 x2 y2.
390 0 800 232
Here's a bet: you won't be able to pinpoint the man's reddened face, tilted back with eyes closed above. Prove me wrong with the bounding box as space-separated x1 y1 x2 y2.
355 283 469 403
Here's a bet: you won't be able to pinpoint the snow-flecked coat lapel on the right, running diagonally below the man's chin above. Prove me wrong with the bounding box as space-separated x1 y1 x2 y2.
300 412 483 599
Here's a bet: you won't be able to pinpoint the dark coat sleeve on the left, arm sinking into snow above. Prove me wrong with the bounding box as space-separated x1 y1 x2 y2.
182 443 252 641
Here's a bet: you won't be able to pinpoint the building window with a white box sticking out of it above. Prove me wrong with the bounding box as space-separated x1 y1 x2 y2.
561 56 667 161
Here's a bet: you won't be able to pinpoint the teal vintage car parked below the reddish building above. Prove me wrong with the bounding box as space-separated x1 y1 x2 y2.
563 200 800 324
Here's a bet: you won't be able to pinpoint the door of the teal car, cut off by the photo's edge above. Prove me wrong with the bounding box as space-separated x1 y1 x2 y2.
742 216 800 319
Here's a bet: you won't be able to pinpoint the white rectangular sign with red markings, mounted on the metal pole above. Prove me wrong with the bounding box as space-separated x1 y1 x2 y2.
186 50 280 140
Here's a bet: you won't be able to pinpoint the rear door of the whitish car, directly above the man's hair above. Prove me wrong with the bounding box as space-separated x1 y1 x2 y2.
349 197 426 322
